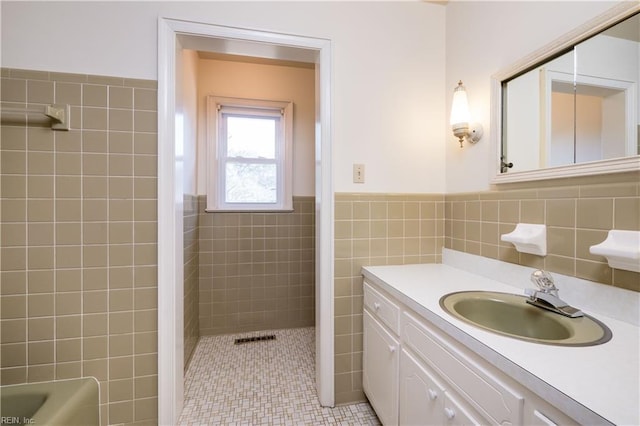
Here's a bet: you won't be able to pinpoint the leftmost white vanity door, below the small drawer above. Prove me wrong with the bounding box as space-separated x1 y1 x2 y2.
362 311 399 425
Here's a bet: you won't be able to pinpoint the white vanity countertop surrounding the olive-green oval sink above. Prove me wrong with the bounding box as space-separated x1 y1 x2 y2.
363 264 640 425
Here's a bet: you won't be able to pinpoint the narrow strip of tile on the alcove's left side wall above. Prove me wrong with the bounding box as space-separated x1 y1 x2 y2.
183 194 200 371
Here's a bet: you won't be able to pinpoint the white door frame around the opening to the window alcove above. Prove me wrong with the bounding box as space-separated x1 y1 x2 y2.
158 18 335 425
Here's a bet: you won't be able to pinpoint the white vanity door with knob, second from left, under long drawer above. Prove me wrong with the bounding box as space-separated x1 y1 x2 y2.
399 349 444 425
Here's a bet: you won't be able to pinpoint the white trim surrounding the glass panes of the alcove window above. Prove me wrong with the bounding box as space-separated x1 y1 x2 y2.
205 95 293 212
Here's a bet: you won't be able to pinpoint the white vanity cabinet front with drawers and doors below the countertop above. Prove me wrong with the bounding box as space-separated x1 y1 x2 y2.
363 280 576 425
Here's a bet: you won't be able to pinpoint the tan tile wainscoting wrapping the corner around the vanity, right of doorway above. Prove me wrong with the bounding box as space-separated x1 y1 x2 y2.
334 182 640 404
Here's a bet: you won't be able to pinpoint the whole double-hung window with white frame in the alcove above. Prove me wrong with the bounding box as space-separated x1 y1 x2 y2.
207 96 293 211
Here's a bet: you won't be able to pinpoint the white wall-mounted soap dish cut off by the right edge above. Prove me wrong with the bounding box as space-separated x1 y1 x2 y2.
589 229 640 272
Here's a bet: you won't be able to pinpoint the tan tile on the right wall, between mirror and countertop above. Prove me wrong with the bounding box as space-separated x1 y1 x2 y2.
445 174 640 291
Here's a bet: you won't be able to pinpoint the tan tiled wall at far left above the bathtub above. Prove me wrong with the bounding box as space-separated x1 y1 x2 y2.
0 69 158 425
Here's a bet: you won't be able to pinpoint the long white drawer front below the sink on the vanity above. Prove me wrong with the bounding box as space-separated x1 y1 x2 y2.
402 312 524 424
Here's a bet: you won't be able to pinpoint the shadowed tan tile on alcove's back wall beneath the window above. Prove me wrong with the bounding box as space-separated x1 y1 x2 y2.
199 196 315 335
